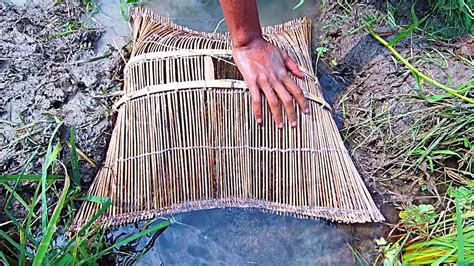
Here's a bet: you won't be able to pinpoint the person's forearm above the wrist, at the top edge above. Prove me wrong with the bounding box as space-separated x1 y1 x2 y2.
220 0 262 47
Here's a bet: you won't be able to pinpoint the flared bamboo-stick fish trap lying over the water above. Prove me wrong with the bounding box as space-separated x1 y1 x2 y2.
73 8 384 230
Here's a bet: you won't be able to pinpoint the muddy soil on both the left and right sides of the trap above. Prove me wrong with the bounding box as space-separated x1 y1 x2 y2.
0 1 472 262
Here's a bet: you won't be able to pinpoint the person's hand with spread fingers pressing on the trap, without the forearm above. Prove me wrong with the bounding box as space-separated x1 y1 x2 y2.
233 38 309 128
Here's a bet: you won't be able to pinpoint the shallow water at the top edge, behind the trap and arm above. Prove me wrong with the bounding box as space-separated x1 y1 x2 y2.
93 0 319 49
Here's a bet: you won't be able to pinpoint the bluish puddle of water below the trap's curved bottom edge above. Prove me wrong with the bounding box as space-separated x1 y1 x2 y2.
112 209 360 265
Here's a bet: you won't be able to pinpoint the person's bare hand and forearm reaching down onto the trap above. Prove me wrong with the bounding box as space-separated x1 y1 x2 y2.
220 0 309 128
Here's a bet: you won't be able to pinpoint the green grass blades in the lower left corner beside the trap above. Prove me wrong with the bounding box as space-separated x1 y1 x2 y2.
0 118 170 265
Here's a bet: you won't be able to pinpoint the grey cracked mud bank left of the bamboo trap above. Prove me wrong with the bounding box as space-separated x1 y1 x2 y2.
0 1 121 222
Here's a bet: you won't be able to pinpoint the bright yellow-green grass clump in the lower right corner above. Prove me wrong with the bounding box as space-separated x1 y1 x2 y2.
382 186 474 265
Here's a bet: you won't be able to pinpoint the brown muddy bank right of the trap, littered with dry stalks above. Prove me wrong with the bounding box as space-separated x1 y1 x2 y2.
320 0 473 202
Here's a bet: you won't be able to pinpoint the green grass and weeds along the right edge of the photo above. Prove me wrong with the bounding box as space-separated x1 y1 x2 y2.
358 1 474 265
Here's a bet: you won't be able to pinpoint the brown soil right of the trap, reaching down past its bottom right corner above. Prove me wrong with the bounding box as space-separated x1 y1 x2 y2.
315 1 473 261
